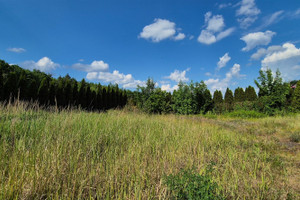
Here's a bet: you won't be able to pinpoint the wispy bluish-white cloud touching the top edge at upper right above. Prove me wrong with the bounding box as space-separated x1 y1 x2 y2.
236 0 260 29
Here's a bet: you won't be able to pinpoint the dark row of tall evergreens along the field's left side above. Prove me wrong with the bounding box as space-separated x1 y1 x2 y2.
0 60 127 110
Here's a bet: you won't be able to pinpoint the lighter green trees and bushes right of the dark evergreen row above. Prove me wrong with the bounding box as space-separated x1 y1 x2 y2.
127 69 300 115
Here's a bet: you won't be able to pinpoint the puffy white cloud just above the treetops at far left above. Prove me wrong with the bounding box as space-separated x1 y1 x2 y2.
20 57 60 72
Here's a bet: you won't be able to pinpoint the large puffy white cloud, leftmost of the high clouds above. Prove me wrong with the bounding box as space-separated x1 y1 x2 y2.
139 19 185 42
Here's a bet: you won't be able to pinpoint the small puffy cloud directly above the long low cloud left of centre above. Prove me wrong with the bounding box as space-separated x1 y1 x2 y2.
72 60 109 72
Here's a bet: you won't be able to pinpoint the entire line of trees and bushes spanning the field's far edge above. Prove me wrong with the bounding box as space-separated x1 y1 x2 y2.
0 60 300 115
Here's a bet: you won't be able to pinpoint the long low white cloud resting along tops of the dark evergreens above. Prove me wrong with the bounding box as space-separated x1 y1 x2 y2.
86 70 145 88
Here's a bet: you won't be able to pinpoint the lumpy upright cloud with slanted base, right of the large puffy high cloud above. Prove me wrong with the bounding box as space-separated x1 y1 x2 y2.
198 12 235 45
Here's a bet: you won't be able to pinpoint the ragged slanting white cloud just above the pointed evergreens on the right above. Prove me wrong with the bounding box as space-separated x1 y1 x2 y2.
204 64 245 92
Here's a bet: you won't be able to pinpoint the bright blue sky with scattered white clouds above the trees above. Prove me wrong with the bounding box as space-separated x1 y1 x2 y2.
0 0 300 92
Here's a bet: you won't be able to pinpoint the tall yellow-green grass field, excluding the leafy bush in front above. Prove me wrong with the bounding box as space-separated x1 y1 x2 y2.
0 104 300 199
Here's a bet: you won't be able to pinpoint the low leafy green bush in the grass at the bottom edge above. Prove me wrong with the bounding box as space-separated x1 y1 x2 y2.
164 166 225 200
